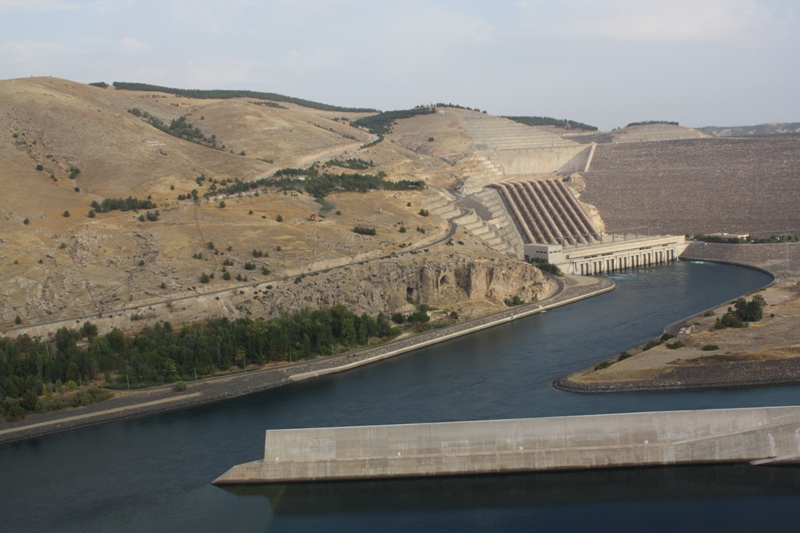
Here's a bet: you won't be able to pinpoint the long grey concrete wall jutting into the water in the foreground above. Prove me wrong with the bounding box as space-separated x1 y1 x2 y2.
214 407 800 484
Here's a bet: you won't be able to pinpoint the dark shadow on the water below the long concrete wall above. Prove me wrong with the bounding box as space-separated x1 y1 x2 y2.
223 465 800 516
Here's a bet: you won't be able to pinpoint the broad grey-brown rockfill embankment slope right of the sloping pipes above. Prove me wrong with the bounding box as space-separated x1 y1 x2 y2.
581 135 800 235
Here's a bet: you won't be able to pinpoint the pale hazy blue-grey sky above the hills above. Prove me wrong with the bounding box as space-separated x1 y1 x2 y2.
0 0 800 130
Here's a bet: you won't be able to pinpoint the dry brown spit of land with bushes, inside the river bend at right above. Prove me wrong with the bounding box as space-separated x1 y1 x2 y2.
553 243 800 393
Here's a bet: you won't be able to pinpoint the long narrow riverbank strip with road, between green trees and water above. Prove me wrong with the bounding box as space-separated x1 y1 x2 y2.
0 276 614 445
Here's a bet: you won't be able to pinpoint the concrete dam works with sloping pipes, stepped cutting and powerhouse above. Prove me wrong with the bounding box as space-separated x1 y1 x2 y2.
438 112 686 270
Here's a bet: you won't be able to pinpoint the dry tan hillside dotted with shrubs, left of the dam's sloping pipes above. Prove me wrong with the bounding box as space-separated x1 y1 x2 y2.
0 78 548 334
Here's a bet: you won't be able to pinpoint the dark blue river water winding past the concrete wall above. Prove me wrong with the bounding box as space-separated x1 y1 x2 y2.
0 262 800 531
